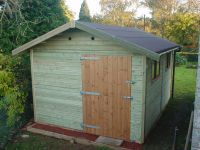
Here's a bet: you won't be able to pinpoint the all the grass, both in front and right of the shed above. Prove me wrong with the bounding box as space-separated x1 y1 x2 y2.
6 66 196 150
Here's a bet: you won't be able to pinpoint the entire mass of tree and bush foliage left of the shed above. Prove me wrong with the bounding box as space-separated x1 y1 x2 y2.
0 0 73 126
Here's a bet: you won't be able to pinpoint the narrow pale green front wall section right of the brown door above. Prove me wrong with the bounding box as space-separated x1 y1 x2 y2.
131 55 146 143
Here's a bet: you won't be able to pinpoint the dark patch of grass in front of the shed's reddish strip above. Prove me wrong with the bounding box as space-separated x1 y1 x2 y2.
5 132 110 150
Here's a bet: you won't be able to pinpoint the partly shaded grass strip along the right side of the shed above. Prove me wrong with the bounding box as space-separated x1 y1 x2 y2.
144 66 196 150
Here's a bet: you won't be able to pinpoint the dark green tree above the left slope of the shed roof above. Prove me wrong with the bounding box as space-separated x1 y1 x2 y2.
0 0 73 53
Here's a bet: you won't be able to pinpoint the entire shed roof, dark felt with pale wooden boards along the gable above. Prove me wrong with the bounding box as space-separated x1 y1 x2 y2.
12 21 180 60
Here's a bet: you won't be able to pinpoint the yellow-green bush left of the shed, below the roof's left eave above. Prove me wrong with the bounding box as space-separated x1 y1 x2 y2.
0 54 28 126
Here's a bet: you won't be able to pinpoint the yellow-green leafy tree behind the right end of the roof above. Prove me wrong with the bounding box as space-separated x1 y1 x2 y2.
166 13 200 48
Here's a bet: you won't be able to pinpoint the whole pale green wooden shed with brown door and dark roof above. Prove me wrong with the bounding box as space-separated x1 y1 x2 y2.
12 21 180 143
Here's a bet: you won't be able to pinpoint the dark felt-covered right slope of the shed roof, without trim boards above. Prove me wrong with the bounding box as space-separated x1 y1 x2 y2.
77 22 179 53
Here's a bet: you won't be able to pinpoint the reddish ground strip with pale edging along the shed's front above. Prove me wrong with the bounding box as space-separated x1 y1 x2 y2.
26 123 142 150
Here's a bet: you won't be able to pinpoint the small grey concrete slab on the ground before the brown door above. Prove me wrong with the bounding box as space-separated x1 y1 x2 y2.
96 136 123 146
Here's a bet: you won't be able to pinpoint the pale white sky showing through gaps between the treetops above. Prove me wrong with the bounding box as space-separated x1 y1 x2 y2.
65 0 151 20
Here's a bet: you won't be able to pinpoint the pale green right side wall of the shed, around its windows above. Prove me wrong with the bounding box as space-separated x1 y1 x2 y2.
145 54 173 136
